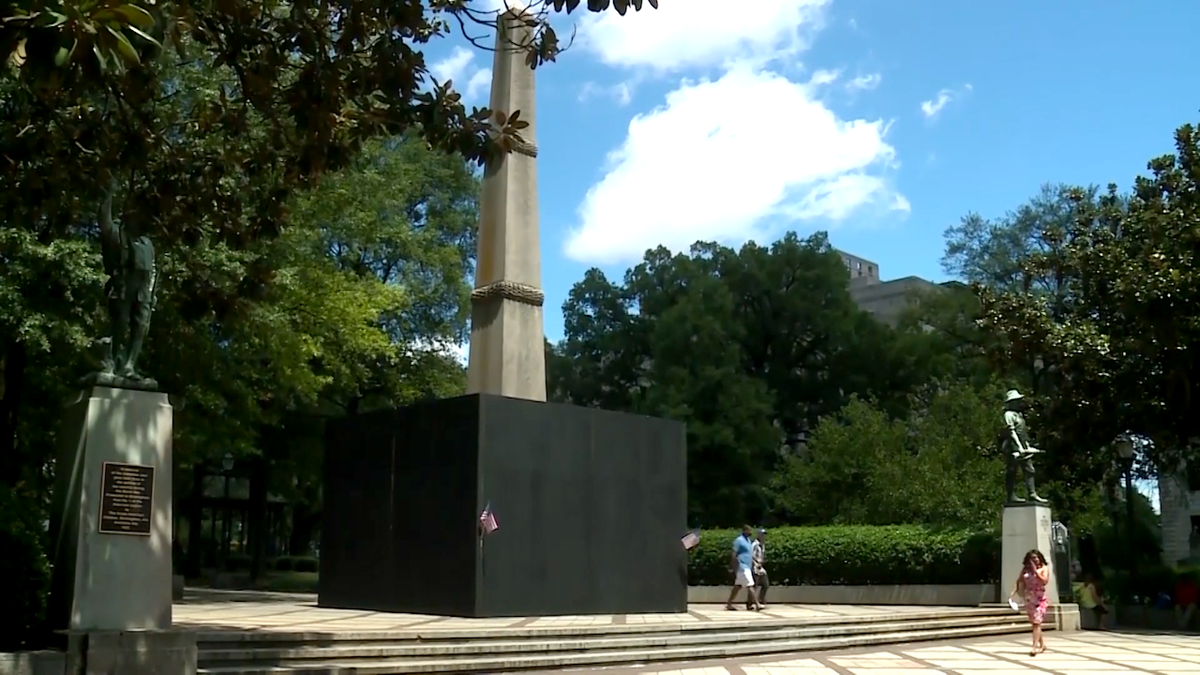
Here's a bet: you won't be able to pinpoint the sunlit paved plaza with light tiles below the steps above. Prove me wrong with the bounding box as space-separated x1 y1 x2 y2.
554 632 1200 675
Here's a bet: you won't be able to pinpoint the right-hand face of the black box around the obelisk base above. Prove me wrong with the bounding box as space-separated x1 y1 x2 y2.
479 396 686 616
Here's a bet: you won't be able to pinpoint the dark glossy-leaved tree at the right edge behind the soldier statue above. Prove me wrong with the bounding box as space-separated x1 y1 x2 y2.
979 120 1200 480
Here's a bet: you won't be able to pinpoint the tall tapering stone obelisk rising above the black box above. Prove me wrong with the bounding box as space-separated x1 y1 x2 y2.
467 10 546 401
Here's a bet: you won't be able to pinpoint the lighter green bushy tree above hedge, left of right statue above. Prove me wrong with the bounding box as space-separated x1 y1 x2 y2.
773 386 1004 527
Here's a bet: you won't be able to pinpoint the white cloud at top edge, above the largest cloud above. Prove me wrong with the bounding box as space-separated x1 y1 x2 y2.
580 0 829 74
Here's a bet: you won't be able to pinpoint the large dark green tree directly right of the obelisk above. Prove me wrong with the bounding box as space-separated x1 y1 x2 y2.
548 234 945 525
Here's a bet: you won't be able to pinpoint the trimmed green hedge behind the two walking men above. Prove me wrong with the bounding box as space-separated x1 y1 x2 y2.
688 525 1000 586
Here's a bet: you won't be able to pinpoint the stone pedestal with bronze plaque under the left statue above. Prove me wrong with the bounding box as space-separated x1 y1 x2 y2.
49 387 172 632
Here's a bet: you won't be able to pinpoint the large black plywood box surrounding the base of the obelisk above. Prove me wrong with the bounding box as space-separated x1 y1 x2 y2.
318 395 688 617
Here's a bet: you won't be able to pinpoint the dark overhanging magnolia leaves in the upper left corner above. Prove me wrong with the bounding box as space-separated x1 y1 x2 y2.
0 0 655 249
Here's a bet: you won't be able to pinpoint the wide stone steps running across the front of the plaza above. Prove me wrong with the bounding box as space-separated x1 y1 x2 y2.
198 608 1028 675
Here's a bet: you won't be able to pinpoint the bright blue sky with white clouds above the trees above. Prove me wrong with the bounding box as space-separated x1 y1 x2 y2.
426 0 1200 340
